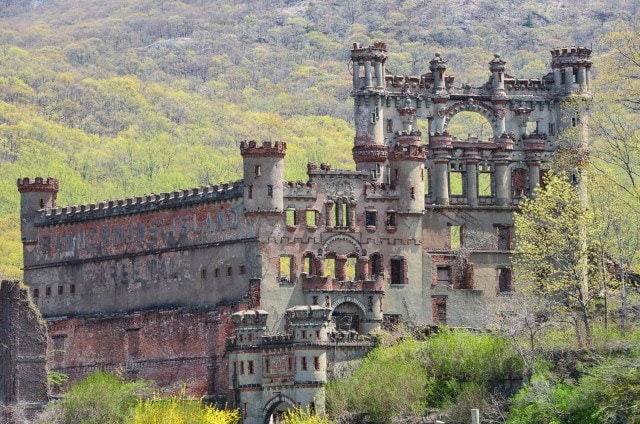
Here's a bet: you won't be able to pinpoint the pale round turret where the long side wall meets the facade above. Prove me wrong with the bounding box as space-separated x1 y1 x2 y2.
240 141 287 212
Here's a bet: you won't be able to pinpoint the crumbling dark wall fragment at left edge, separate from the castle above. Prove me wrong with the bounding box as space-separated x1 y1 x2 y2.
0 281 48 416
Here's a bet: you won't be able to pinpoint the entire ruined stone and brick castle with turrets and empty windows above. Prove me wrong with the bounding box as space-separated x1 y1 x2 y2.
18 43 591 423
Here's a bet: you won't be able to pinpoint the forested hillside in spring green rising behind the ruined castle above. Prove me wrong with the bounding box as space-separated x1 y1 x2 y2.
0 0 640 278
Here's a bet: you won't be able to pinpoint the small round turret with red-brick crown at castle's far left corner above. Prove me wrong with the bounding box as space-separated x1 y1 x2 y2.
18 177 59 258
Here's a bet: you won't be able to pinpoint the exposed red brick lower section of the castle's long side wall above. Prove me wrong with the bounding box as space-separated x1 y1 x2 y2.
49 303 247 397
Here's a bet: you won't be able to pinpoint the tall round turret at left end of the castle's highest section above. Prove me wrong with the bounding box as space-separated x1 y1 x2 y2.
351 42 387 181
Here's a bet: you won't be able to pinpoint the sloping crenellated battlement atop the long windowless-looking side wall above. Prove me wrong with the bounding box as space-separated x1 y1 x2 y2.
35 180 244 226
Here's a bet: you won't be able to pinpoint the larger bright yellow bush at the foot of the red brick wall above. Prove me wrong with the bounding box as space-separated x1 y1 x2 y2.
133 396 240 424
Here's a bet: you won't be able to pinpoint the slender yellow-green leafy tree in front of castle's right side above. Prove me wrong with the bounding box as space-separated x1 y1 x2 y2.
512 172 598 346
